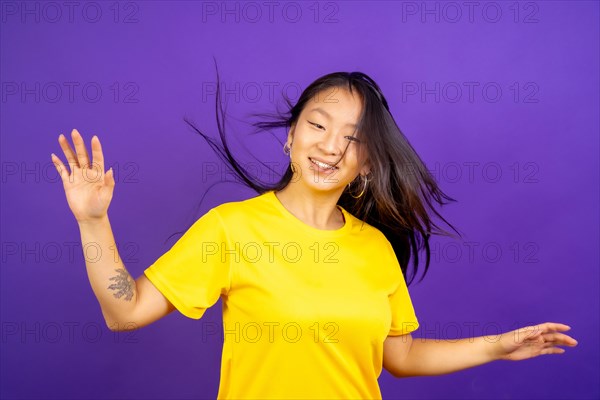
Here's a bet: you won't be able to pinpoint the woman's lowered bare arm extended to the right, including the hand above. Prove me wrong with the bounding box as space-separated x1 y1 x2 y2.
384 322 577 378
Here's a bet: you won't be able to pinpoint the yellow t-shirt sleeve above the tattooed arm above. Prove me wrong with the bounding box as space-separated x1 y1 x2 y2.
144 209 231 319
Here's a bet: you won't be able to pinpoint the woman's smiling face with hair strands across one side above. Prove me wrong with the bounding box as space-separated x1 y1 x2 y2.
287 88 369 195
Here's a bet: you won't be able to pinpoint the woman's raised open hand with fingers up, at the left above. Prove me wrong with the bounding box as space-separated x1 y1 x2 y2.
52 129 115 223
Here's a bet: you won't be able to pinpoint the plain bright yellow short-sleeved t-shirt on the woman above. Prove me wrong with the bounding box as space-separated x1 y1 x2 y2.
144 191 419 399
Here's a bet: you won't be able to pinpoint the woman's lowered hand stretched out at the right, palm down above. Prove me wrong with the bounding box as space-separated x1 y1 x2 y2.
496 322 577 361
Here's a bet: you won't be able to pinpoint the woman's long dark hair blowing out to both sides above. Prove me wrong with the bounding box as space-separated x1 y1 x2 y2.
176 61 460 285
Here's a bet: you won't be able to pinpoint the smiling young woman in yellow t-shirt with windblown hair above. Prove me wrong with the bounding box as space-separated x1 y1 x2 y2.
52 72 577 399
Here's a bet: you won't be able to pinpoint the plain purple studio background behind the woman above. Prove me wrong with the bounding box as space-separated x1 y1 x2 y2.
0 1 600 399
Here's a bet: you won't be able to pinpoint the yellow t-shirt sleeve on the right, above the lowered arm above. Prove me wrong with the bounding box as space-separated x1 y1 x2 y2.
388 244 419 336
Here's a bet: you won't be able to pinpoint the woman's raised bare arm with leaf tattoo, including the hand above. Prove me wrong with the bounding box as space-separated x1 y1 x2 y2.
52 129 175 331
